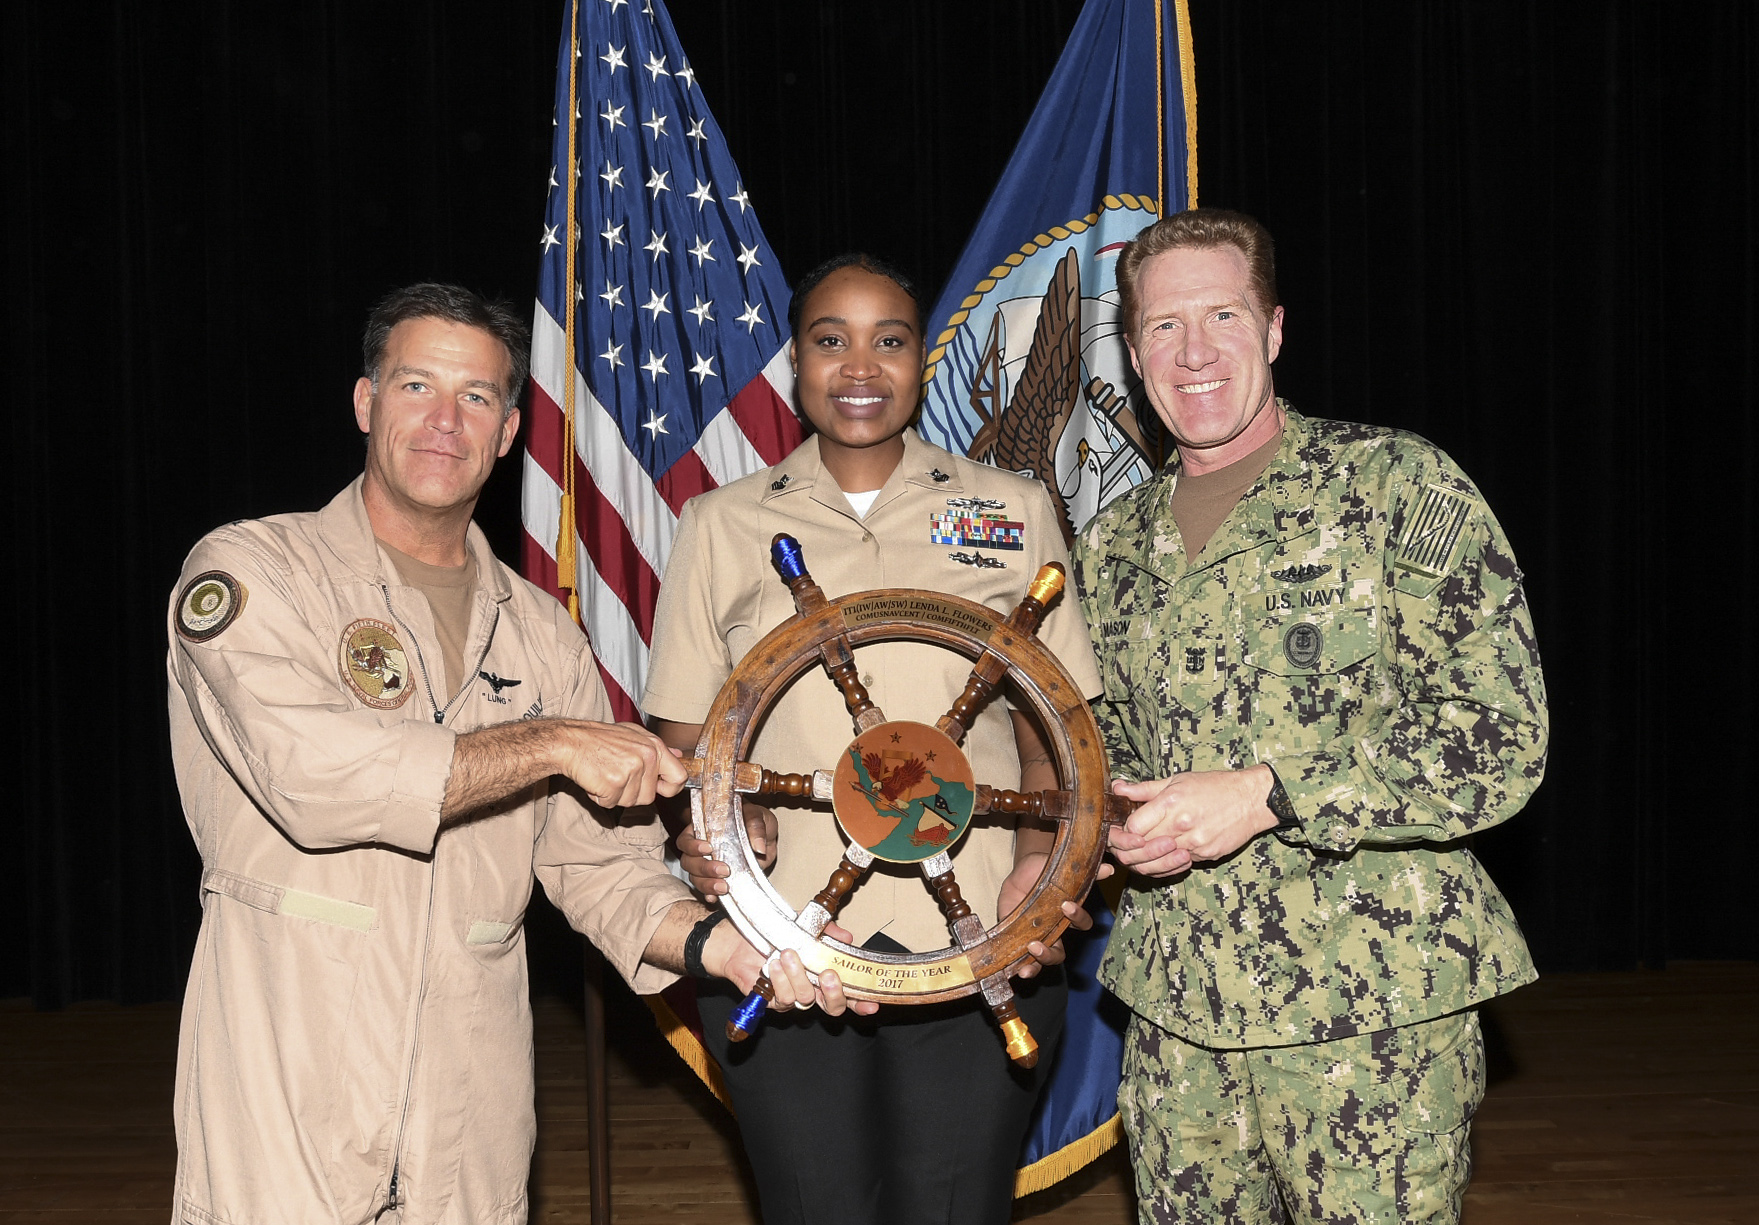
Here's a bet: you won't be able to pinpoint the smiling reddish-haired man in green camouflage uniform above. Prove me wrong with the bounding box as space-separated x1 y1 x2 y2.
1073 209 1546 1221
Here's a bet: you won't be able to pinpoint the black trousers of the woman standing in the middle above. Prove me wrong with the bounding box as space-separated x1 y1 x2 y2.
697 966 1068 1225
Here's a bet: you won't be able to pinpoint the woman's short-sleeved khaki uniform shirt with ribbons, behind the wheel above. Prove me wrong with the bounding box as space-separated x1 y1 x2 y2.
642 431 1099 952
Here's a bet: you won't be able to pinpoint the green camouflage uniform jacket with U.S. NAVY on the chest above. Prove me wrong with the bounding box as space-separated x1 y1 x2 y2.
1073 412 1546 1047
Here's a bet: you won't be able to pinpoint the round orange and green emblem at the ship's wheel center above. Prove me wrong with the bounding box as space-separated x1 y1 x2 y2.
830 722 978 864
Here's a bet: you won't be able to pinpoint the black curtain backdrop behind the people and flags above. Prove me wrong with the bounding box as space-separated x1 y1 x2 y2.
0 0 1759 1007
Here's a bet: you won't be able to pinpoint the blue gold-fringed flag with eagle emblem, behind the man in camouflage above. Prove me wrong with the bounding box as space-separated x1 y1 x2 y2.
920 0 1196 1195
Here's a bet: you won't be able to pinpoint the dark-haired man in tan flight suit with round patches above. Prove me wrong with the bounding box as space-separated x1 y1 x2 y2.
167 285 843 1225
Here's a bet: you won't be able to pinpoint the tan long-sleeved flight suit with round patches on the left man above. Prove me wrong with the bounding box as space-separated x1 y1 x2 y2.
167 480 691 1225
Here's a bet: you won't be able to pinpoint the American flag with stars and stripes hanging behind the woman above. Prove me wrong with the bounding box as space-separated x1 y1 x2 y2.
522 0 800 718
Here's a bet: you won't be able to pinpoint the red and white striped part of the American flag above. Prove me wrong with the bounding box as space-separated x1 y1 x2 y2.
522 303 800 720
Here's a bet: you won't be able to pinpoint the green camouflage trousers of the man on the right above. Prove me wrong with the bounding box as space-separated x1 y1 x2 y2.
1117 1010 1485 1225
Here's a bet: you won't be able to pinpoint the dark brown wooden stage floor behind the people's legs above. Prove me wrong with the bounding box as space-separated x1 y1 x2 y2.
0 963 1759 1225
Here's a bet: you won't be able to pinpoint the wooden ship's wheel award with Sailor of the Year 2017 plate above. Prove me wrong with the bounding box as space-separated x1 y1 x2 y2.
688 535 1133 1067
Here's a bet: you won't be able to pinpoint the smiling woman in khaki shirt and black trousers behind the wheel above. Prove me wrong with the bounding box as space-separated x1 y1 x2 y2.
642 255 1099 1225
